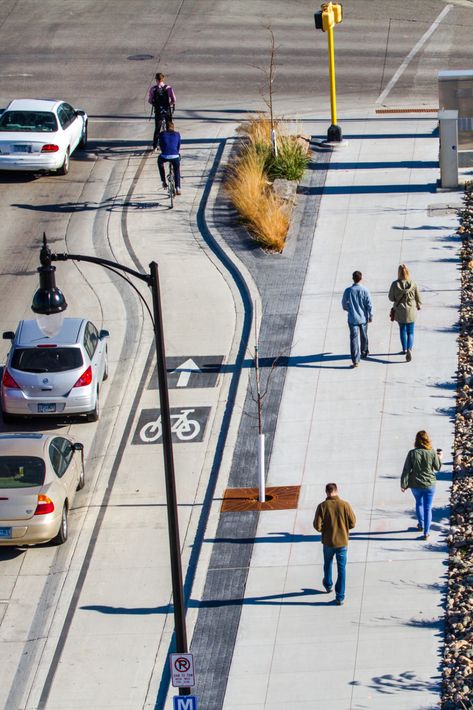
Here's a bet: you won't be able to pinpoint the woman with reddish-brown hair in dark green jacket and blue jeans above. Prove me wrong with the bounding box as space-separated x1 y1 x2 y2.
401 430 442 540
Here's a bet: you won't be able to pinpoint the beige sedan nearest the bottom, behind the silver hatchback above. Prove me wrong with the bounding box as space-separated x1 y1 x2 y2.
0 434 85 546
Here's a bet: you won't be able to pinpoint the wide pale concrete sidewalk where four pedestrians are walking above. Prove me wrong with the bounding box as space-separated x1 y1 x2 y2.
224 117 461 710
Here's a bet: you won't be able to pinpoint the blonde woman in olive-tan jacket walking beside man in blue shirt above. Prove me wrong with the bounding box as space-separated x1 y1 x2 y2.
388 264 422 362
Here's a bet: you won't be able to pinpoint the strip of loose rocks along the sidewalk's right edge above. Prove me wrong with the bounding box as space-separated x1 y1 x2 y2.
442 182 473 710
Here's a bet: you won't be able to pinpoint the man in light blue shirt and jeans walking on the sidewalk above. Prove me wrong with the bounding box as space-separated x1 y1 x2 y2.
342 271 373 367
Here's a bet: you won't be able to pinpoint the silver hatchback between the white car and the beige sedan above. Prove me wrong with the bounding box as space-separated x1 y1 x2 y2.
0 318 109 423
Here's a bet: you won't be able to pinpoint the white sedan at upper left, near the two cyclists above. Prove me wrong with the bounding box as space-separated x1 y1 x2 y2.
0 99 88 175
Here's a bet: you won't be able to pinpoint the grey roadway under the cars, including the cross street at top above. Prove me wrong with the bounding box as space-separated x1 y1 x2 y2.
0 0 473 710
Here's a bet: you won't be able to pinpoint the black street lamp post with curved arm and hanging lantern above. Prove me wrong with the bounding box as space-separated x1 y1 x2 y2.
31 234 190 695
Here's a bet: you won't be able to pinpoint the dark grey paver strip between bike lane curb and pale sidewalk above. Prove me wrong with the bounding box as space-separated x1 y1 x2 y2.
191 139 331 710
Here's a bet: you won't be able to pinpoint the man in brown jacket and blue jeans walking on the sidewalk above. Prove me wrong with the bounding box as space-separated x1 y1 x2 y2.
314 483 356 606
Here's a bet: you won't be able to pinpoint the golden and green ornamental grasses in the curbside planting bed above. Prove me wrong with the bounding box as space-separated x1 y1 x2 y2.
225 114 308 251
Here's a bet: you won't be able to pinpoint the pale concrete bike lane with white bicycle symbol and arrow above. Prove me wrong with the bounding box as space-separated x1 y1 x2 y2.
24 124 254 708
